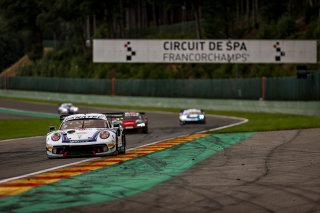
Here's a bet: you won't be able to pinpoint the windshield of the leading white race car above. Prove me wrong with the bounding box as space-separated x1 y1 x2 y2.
60 119 108 130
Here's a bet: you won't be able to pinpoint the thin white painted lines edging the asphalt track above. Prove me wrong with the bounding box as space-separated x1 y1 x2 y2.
0 116 248 183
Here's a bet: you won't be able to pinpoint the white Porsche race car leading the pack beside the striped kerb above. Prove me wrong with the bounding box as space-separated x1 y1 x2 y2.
46 113 126 158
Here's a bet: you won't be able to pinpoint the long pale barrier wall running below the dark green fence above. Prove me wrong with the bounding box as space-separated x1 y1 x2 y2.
0 90 320 116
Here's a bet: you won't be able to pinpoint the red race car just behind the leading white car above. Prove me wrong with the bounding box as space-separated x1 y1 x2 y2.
122 112 148 133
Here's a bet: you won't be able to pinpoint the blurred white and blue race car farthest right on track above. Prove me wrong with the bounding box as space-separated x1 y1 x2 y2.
179 109 206 125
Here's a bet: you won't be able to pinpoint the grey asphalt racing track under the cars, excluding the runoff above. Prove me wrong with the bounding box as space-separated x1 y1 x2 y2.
0 99 239 180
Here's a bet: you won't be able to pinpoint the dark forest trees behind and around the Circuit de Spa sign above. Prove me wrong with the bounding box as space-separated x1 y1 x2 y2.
0 0 320 78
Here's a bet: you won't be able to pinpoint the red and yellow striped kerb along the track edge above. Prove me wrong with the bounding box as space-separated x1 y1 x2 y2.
0 134 208 197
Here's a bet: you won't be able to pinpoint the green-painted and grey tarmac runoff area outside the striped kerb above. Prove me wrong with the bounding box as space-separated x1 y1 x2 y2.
0 129 320 213
